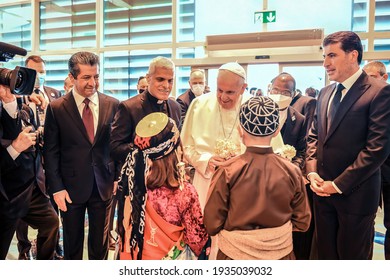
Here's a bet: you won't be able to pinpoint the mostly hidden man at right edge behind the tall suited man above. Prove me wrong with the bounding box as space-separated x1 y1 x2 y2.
363 60 390 260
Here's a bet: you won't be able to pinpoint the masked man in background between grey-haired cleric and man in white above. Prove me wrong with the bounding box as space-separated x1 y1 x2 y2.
176 69 206 124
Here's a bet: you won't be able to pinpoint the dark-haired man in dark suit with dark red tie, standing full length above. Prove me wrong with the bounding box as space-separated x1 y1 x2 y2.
43 52 119 260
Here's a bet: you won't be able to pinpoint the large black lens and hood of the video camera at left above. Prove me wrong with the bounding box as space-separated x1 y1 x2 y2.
0 66 37 95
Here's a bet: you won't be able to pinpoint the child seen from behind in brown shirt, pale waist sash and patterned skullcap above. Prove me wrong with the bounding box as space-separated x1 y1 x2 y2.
204 97 311 260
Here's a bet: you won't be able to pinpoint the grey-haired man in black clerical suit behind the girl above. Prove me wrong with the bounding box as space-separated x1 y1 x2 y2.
110 56 180 254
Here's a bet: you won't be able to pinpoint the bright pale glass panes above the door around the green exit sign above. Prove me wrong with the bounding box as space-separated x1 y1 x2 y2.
195 0 352 38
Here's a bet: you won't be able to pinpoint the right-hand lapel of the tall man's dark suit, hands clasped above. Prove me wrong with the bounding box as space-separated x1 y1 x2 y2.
325 73 370 141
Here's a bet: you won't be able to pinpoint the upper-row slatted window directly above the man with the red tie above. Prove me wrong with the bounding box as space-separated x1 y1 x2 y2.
40 0 96 50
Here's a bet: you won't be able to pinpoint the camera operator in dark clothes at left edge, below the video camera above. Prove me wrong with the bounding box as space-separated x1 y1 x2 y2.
0 85 59 260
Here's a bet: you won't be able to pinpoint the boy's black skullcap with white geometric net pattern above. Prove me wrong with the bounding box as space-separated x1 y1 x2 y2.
240 96 279 136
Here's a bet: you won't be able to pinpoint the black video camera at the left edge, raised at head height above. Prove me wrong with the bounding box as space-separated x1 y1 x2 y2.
0 42 37 95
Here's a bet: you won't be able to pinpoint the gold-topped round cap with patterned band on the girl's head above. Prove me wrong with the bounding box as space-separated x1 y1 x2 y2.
134 113 180 160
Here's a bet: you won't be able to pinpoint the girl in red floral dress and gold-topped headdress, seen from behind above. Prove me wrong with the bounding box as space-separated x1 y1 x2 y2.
119 113 208 260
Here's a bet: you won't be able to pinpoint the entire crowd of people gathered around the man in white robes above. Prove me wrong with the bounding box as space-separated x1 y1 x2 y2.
0 31 390 260
